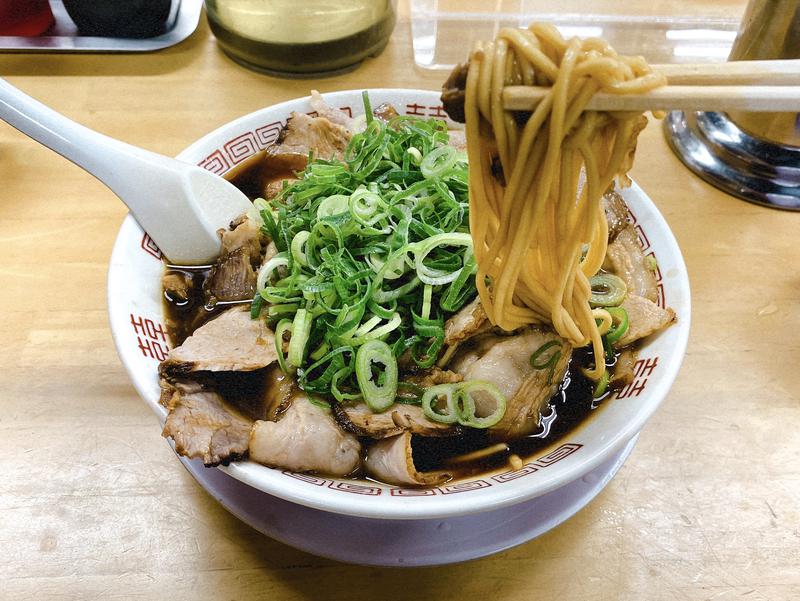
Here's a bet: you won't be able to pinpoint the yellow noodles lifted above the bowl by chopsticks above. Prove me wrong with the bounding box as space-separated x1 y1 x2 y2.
464 24 666 379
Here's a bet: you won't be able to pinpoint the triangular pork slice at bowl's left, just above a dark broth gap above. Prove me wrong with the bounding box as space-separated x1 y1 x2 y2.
159 307 278 377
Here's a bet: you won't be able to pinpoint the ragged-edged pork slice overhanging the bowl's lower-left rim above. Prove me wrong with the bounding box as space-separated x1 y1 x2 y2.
162 382 253 467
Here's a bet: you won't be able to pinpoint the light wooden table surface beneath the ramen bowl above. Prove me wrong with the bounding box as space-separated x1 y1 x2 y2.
0 2 800 601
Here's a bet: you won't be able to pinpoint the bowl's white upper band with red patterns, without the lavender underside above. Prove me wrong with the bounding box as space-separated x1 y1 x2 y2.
108 89 690 520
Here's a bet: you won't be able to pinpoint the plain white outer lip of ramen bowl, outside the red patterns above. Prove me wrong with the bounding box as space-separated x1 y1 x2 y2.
108 88 691 520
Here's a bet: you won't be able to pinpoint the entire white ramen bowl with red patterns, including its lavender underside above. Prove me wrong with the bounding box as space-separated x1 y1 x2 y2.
108 89 690 565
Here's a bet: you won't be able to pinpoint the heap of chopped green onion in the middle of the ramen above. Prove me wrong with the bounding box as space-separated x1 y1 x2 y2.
253 96 484 418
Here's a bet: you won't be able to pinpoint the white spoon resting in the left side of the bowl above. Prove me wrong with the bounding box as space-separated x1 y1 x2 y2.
0 79 251 265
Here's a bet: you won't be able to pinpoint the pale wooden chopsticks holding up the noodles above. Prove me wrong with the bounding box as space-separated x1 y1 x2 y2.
503 60 800 112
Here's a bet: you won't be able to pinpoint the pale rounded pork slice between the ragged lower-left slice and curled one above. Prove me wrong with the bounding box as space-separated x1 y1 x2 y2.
249 393 361 476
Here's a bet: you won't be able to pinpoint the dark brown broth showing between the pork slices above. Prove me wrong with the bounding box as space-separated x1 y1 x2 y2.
164 151 612 480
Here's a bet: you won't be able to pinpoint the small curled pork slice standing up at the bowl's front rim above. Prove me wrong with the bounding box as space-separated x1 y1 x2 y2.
364 432 452 486
